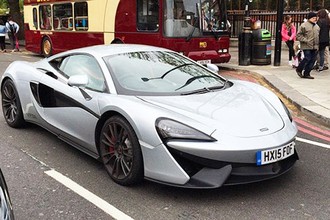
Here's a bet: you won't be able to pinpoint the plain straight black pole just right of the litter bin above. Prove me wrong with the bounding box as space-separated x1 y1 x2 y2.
274 0 284 66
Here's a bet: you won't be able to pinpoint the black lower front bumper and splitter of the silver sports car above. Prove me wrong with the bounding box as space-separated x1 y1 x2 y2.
149 149 299 189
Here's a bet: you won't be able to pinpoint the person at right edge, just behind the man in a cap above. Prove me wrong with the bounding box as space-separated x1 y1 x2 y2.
317 9 330 71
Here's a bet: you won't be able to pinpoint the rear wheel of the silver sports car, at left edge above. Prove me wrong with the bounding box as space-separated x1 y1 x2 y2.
1 79 25 128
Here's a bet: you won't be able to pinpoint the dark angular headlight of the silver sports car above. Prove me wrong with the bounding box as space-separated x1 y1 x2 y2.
156 118 216 141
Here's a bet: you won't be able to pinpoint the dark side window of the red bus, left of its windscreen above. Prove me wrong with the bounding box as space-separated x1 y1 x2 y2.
137 0 159 31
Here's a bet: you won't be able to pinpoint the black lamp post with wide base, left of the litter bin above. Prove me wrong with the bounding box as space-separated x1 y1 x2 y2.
238 0 252 66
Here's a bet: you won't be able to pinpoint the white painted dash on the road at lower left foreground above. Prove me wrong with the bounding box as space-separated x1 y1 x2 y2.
45 169 133 220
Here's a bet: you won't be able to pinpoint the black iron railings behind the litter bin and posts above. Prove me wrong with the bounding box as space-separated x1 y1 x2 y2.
228 11 308 39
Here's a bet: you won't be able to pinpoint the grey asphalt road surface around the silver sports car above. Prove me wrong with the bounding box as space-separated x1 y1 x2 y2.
0 50 330 220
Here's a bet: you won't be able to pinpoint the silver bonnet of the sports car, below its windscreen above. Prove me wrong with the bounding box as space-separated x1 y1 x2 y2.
140 84 284 137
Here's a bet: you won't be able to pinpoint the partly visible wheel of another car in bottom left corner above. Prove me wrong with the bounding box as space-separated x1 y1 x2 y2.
0 169 14 220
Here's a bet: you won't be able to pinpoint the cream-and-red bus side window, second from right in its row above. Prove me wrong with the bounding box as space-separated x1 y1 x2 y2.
53 3 73 30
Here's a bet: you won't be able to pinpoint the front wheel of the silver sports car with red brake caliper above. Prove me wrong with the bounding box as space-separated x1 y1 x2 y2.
99 116 144 186
